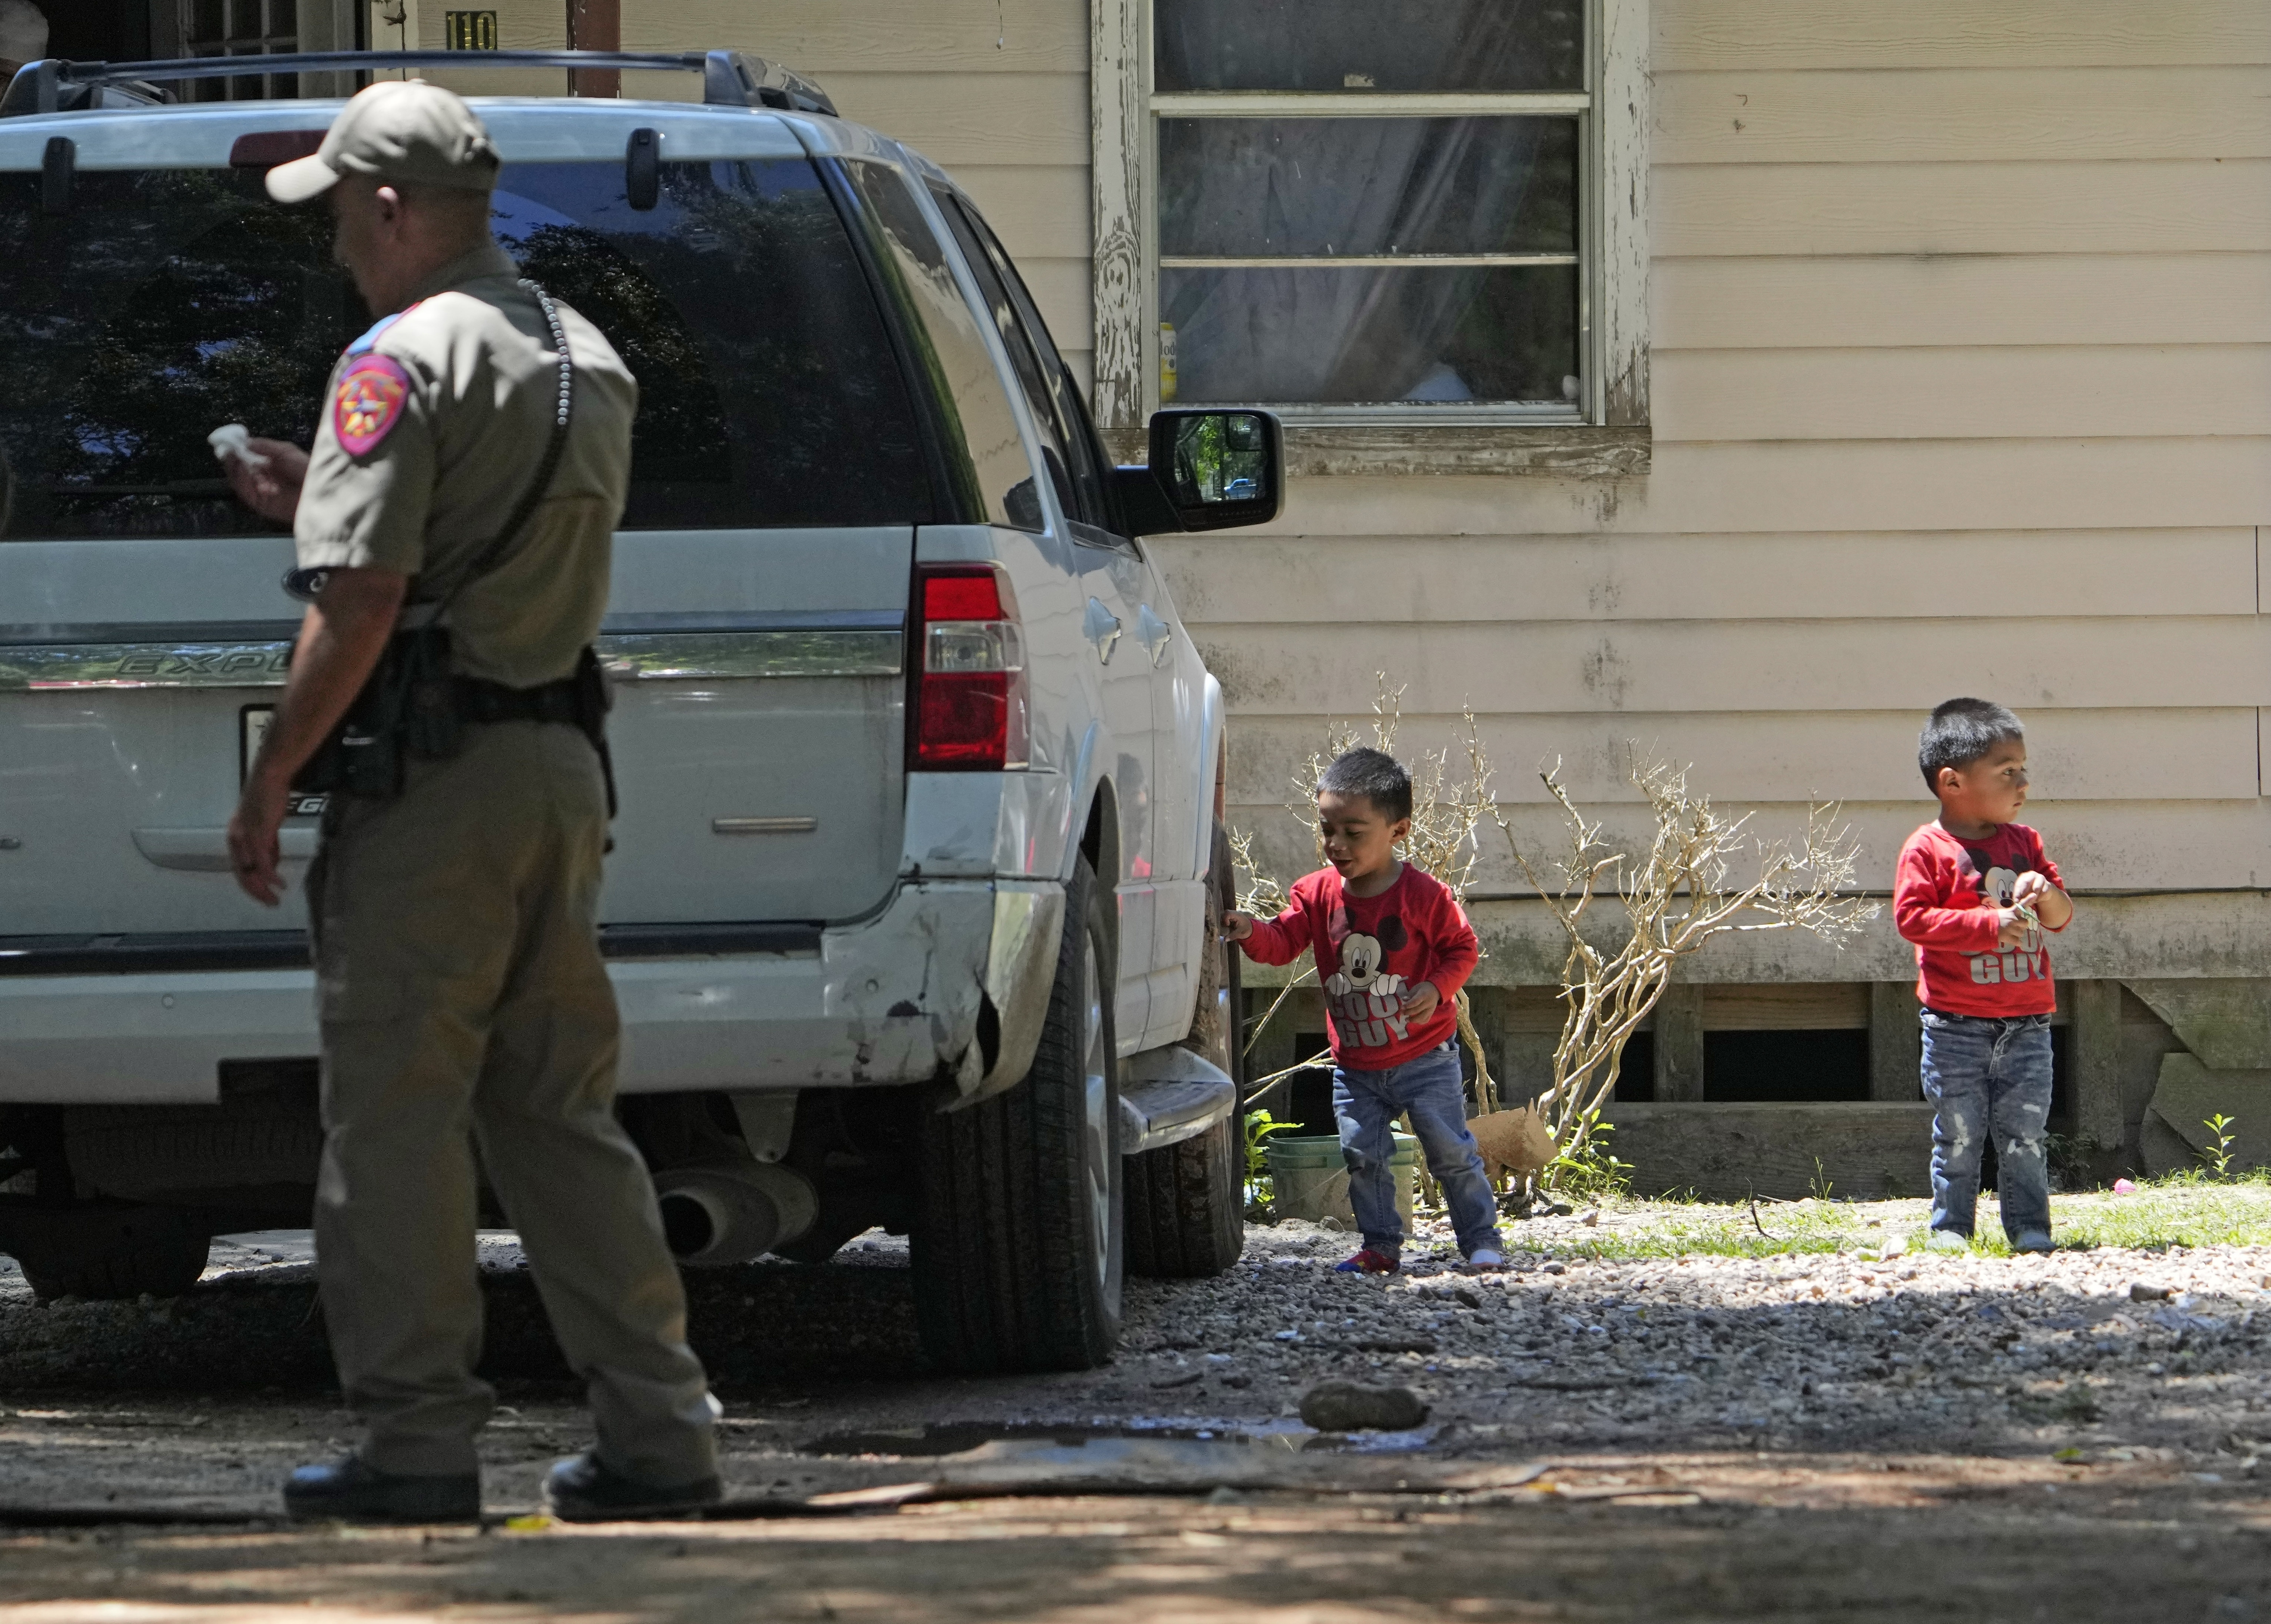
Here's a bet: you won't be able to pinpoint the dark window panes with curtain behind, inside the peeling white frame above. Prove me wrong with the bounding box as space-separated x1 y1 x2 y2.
1154 0 1590 409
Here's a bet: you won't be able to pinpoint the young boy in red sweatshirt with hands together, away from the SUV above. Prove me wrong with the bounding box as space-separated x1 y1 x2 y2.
1892 699 2073 1252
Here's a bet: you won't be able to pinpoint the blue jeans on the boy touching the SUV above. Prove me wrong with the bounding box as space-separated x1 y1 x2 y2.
1333 1043 1503 1256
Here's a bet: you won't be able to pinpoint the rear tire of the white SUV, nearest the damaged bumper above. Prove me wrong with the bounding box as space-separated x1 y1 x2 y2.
913 859 1122 1374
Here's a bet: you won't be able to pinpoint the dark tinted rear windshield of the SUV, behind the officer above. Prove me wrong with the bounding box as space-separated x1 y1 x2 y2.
0 159 934 538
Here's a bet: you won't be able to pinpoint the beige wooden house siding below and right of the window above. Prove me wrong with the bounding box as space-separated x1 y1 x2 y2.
1158 0 2271 979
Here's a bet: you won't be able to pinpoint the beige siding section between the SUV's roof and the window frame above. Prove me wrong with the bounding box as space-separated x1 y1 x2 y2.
613 0 1095 382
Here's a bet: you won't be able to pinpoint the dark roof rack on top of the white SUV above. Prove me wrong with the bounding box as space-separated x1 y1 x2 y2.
0 50 838 118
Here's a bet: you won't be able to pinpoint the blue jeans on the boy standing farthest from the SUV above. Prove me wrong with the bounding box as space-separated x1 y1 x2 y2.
1924 1009 2051 1242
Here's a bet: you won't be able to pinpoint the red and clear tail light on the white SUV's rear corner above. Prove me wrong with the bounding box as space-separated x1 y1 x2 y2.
913 563 1026 772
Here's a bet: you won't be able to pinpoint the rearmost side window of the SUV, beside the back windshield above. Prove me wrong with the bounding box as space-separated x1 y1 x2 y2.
845 164 1042 529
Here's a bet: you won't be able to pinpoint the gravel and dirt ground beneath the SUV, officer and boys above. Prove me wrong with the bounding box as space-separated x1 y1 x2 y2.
0 1204 2271 1624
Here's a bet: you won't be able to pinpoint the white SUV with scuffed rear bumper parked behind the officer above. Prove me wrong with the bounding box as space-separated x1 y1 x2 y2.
0 52 1281 1370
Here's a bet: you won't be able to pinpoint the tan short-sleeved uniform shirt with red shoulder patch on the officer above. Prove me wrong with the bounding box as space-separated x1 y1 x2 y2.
293 243 638 688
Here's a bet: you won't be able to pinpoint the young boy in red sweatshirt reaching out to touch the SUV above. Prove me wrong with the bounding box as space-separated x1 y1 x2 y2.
1222 749 1506 1274
